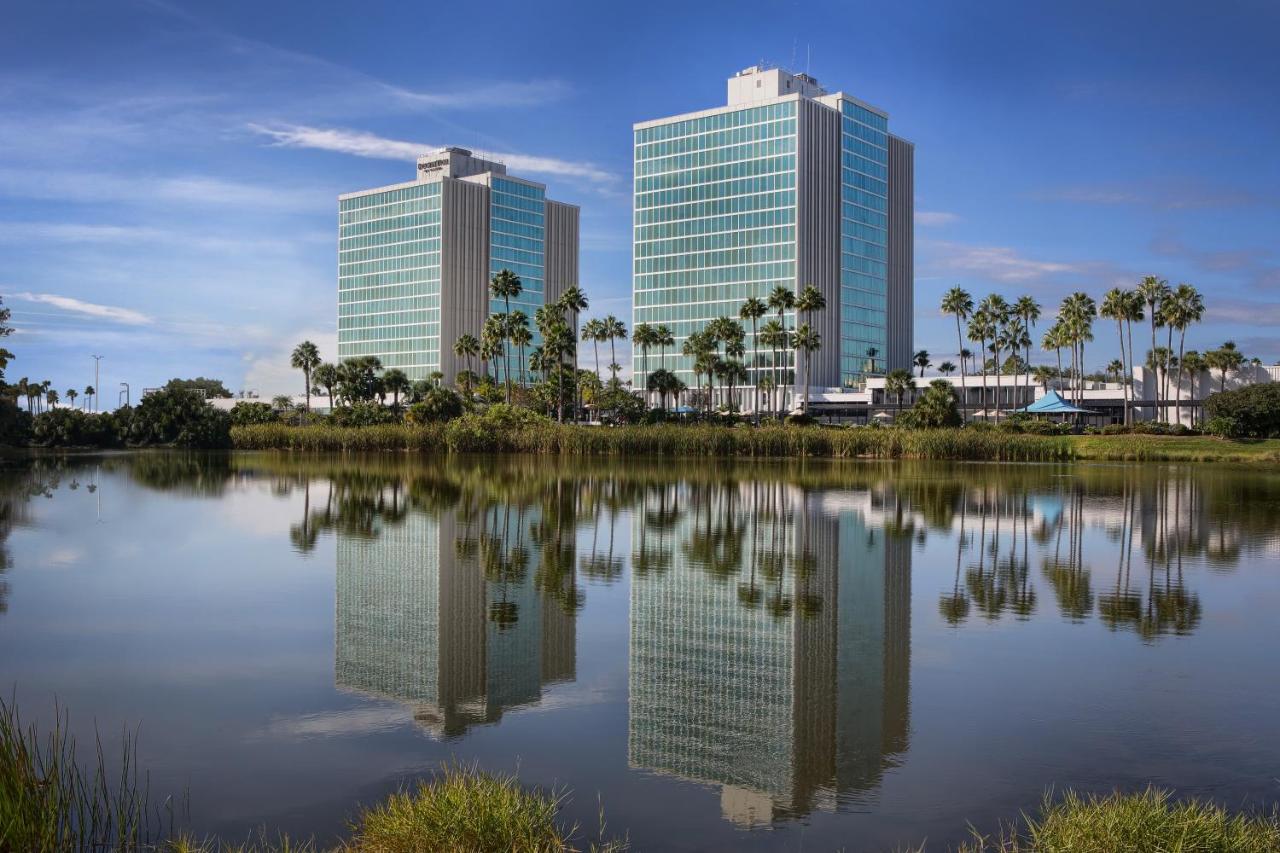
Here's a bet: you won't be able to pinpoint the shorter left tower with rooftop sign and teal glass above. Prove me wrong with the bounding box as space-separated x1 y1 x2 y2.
338 149 579 382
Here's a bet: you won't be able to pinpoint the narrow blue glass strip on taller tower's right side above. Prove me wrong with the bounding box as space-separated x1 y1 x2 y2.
840 99 888 386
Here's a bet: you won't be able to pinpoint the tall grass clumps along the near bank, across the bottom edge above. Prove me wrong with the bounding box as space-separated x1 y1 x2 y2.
0 699 1280 853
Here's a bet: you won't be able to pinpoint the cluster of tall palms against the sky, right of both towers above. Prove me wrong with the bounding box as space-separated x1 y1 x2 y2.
942 275 1257 424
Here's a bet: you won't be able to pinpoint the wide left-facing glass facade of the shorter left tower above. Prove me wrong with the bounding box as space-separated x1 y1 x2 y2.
338 182 440 371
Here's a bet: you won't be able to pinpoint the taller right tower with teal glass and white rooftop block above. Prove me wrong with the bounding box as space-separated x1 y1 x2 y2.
634 67 914 397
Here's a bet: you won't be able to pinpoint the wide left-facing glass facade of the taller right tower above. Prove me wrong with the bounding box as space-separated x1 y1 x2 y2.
634 101 796 387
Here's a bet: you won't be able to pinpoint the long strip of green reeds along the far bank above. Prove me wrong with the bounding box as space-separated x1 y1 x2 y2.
230 415 1280 462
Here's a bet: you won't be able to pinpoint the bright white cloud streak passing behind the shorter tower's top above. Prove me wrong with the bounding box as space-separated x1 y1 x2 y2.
248 123 617 184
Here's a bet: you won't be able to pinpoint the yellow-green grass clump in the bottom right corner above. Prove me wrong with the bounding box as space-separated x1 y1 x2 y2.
957 788 1280 853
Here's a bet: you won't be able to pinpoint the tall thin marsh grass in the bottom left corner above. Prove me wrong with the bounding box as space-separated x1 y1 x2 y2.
0 698 174 850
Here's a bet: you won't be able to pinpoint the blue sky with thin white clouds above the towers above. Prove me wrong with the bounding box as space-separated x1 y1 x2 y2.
0 0 1280 398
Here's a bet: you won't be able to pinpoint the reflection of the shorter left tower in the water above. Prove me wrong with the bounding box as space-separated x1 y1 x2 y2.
334 510 577 736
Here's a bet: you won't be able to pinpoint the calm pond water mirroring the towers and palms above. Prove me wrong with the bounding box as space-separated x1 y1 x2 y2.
0 453 1280 850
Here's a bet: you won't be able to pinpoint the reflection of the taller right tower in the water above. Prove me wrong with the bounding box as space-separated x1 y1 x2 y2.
628 483 910 825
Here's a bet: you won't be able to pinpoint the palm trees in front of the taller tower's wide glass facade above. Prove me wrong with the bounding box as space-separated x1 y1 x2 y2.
634 284 827 420
